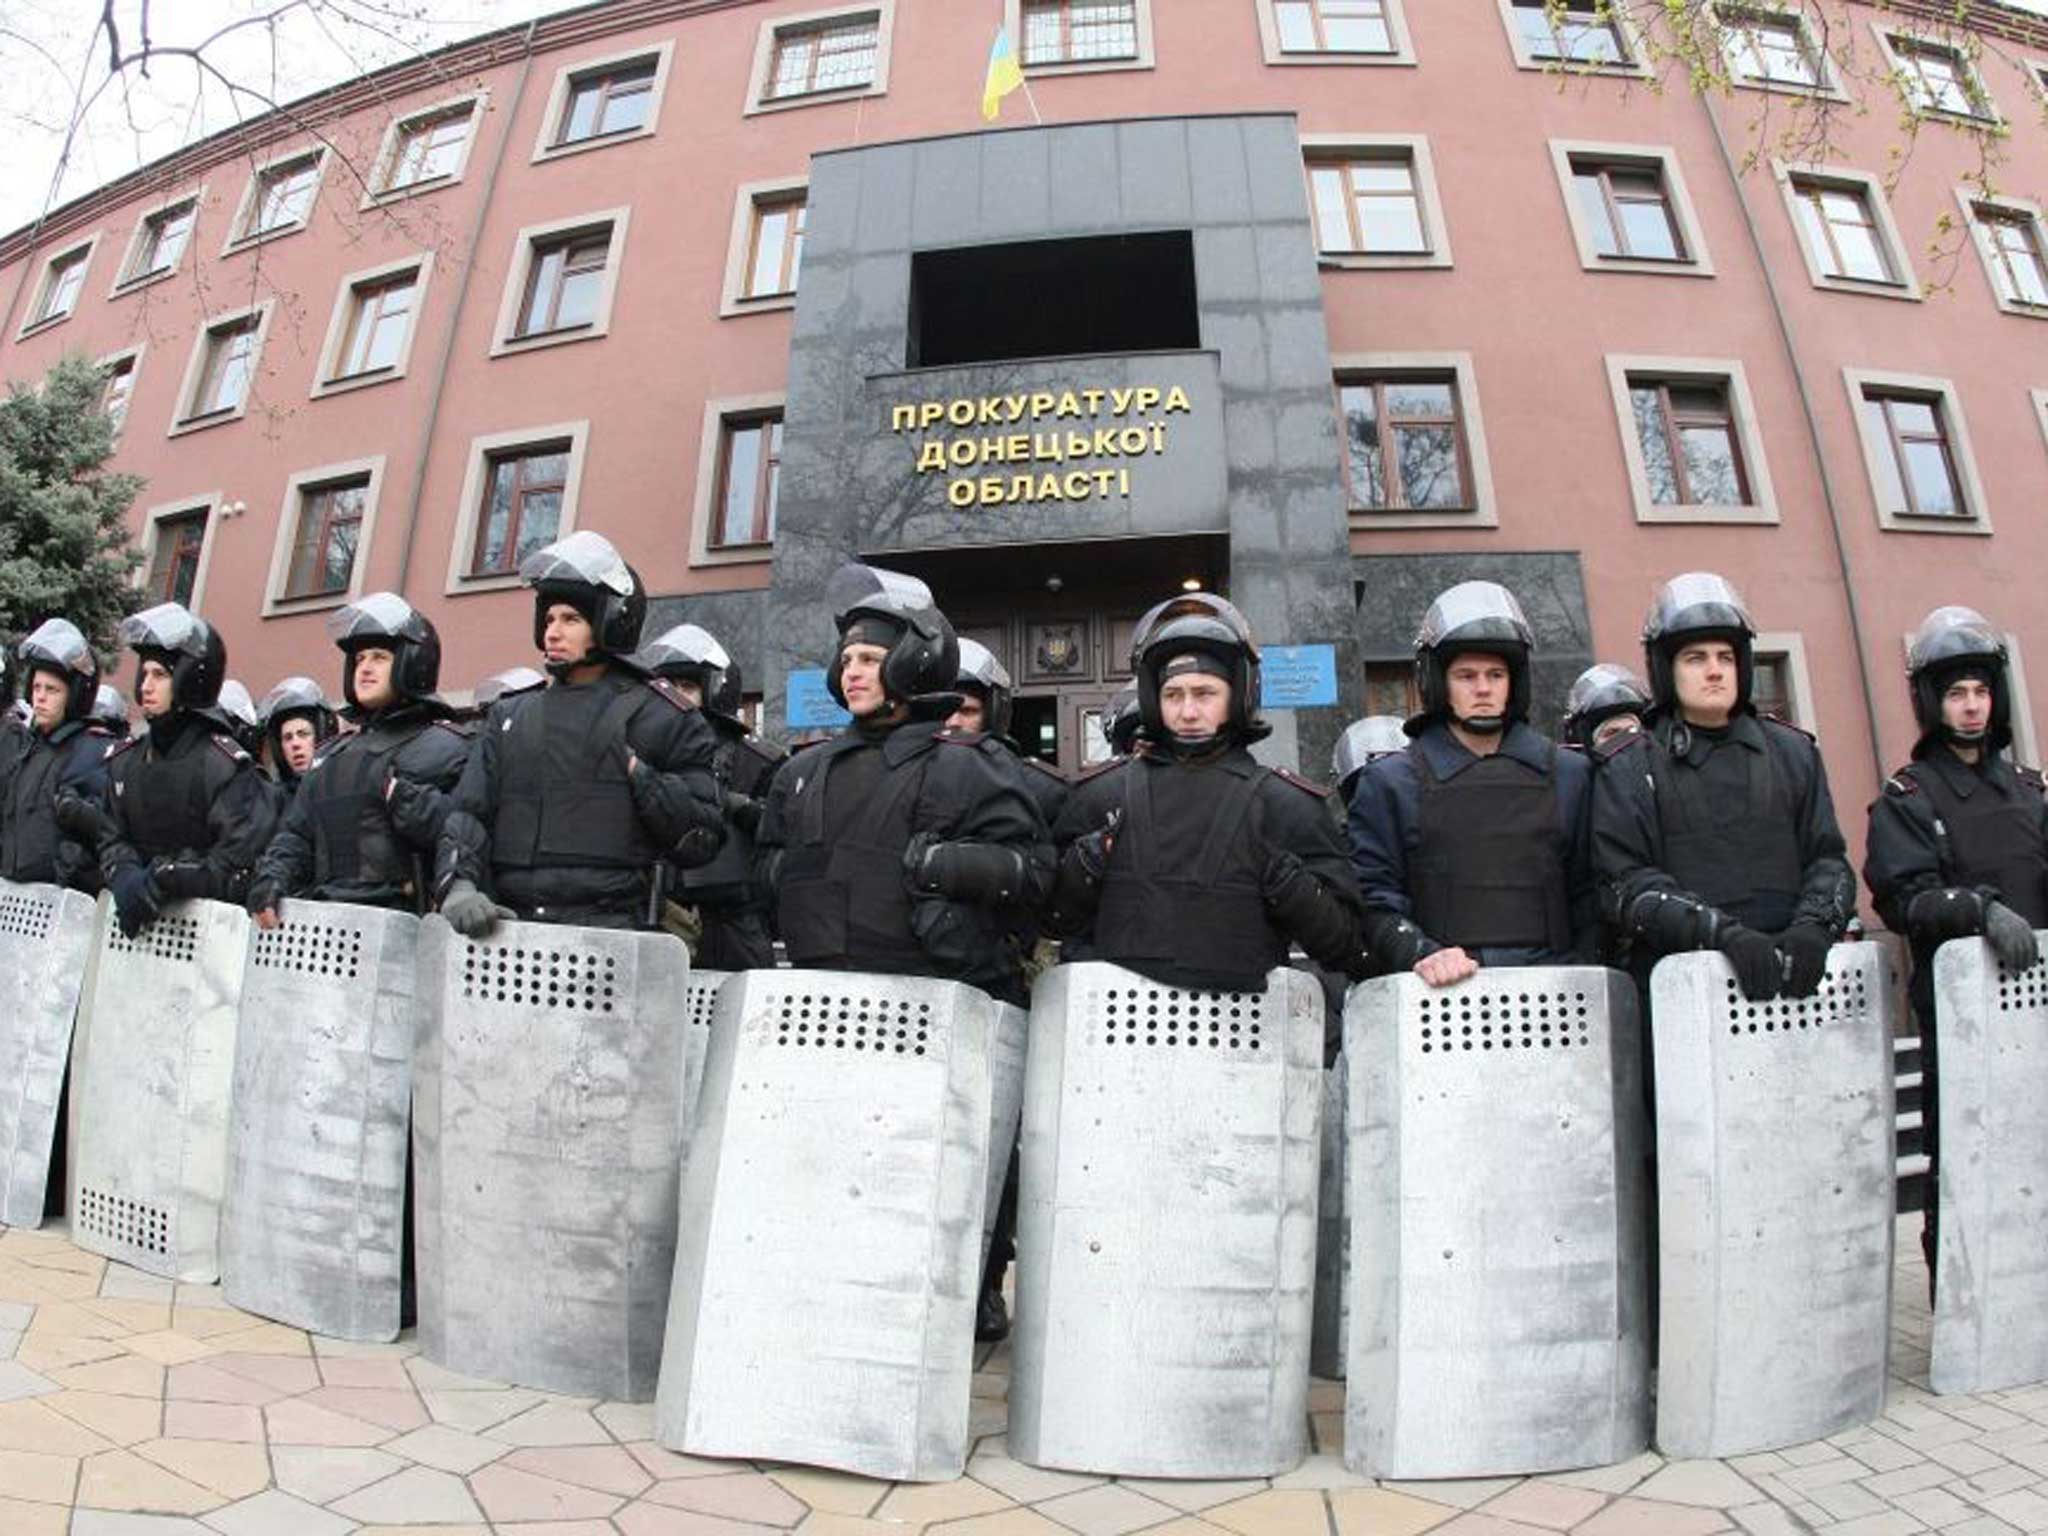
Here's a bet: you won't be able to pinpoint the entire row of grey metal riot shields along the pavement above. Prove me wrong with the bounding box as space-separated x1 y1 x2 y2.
0 885 2048 1481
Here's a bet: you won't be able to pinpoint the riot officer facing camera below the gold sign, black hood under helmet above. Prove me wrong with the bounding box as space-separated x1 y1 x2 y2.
1049 592 1362 991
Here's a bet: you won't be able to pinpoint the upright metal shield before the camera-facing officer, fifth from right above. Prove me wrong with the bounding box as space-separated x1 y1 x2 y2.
1010 961 1325 1477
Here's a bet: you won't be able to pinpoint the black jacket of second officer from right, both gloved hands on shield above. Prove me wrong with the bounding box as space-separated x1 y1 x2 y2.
1593 715 1855 963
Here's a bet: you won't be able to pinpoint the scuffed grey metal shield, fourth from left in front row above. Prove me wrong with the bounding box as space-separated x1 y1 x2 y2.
412 918 690 1401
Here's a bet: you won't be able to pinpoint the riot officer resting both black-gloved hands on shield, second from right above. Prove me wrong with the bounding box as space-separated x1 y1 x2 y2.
1593 571 1855 999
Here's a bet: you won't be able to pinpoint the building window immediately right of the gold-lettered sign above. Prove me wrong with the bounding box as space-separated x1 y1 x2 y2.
1337 373 1473 512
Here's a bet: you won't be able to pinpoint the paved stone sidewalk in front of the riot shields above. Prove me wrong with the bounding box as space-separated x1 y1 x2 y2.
0 1219 2048 1536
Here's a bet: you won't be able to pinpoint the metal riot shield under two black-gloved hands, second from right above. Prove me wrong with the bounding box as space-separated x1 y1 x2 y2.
1651 944 1894 1456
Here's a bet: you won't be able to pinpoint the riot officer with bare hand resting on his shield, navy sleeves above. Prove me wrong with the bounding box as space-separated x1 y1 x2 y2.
1350 582 1599 987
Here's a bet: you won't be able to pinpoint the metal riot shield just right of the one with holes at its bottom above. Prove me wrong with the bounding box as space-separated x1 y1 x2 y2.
221 901 420 1339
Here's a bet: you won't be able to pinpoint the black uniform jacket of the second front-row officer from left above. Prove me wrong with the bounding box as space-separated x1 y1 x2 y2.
100 711 276 903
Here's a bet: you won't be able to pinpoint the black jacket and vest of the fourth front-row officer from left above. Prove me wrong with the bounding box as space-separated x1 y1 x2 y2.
434 668 725 928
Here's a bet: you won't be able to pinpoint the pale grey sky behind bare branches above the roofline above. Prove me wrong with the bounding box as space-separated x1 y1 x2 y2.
0 0 571 231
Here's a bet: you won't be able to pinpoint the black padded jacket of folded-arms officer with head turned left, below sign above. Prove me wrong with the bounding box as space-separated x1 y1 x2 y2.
760 721 1053 999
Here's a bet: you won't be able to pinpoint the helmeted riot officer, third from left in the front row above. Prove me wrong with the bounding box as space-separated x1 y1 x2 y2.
248 592 469 928
